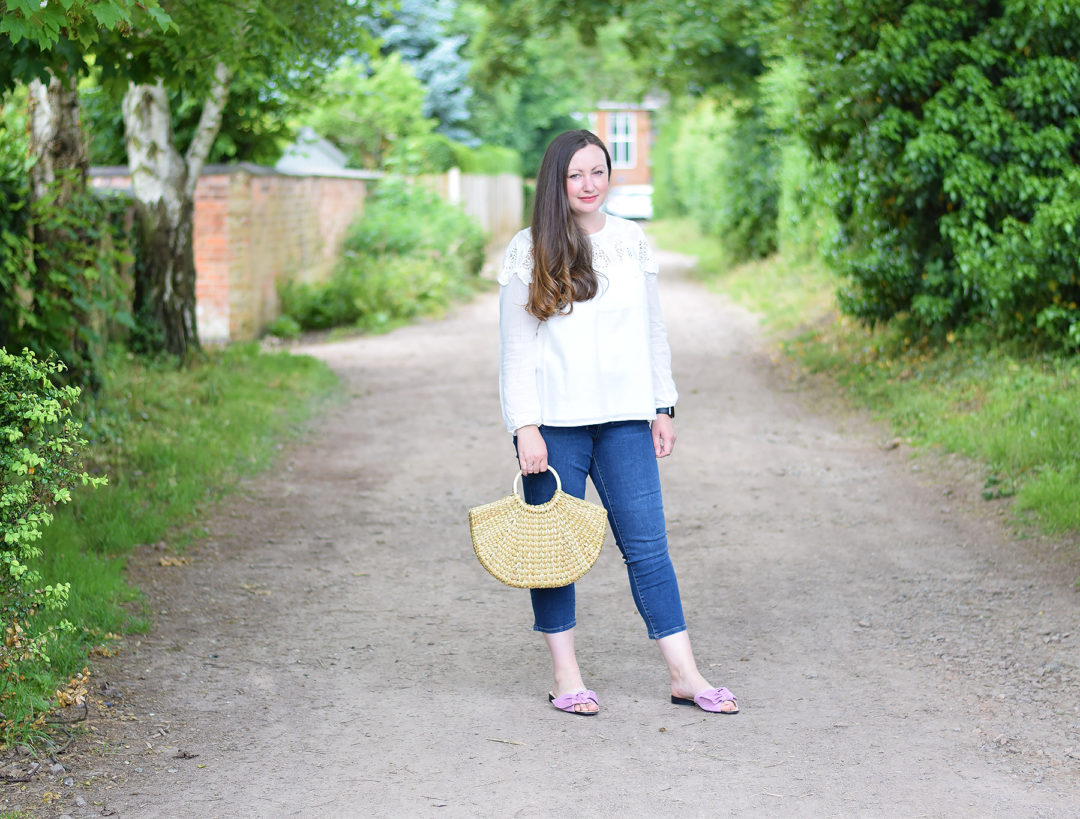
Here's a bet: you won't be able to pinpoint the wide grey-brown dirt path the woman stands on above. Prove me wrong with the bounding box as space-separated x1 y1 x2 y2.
10 255 1080 819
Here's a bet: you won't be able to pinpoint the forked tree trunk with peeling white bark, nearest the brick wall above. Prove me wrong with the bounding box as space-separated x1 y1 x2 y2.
123 63 230 357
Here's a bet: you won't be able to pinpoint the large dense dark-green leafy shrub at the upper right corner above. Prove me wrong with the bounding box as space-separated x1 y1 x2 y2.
801 0 1080 350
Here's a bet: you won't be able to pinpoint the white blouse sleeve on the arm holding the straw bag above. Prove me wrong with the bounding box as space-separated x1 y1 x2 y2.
499 257 542 432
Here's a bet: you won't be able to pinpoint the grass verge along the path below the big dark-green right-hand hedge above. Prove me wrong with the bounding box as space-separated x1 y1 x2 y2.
649 219 1080 544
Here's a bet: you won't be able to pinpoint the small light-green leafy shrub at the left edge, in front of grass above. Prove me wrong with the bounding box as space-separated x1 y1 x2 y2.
0 347 105 721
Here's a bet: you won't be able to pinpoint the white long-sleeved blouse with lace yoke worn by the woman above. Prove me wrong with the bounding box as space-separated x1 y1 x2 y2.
498 214 678 432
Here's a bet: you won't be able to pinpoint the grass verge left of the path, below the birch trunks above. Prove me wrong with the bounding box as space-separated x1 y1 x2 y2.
0 345 337 747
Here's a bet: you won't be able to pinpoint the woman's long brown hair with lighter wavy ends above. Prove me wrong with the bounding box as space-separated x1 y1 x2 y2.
526 131 611 321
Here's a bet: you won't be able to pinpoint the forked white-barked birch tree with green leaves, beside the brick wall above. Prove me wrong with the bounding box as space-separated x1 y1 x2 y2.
99 0 374 357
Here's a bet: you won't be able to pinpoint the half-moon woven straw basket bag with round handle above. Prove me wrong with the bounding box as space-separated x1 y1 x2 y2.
469 467 607 589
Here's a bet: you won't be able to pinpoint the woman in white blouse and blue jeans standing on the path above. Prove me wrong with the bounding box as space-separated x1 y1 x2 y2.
499 131 739 715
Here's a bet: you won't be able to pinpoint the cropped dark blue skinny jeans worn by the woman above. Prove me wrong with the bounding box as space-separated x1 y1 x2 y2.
515 420 686 640
